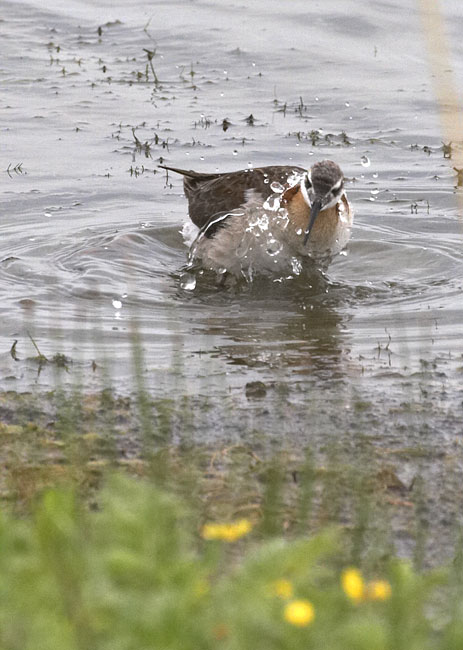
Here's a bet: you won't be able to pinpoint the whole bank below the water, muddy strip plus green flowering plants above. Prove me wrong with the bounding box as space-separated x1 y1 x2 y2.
0 374 463 650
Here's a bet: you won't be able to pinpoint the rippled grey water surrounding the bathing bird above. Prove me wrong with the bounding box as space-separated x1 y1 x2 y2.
0 0 463 552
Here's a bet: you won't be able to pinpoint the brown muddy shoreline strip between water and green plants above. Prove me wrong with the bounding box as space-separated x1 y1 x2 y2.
0 389 461 568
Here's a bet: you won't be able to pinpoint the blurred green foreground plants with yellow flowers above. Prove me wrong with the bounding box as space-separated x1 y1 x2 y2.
0 475 463 650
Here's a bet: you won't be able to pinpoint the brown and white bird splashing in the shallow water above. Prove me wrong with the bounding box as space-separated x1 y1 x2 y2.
160 160 353 280
